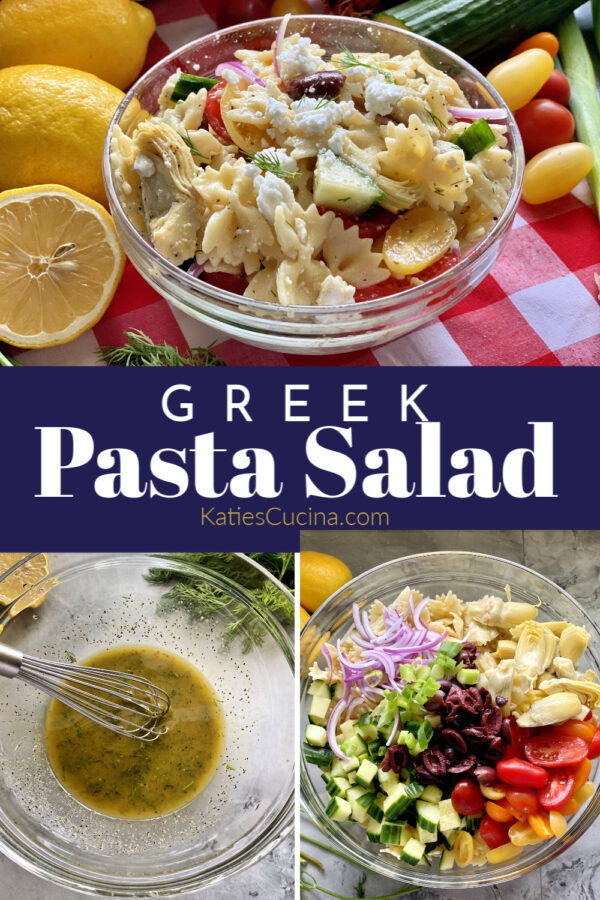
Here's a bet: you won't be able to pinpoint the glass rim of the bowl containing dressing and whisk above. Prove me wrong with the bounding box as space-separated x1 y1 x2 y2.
0 553 294 900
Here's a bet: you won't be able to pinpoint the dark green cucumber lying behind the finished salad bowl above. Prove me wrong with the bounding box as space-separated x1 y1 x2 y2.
374 0 581 65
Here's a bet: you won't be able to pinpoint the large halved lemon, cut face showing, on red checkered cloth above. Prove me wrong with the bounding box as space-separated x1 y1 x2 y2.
0 184 125 348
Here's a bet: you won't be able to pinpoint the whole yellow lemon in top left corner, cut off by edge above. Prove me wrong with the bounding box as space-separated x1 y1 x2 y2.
0 0 155 88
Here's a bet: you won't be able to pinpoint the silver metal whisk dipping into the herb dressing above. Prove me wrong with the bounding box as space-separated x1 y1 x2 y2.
0 644 170 741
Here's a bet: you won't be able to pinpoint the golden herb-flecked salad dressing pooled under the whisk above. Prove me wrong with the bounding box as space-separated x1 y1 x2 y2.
46 646 225 819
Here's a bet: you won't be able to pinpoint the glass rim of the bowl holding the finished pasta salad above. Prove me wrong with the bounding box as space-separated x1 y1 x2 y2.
102 15 525 321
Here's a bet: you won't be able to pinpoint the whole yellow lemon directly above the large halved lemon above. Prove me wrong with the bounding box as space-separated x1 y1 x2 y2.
0 65 123 204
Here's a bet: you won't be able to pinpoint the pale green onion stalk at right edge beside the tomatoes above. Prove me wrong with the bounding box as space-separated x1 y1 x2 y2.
556 14 600 216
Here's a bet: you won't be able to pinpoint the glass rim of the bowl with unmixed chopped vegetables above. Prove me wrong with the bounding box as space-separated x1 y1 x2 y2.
298 550 600 890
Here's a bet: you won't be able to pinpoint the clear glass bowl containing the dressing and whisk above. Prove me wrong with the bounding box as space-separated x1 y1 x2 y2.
0 554 294 898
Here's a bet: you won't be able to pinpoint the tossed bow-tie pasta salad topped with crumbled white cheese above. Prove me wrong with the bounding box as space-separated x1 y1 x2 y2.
111 17 511 307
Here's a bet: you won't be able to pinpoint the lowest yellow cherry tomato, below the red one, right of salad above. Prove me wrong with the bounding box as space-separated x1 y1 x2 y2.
523 141 594 205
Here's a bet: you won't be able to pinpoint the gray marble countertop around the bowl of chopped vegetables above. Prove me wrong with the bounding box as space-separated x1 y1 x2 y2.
300 531 600 900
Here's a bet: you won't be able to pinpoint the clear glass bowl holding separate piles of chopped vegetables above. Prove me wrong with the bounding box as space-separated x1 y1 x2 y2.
300 551 600 890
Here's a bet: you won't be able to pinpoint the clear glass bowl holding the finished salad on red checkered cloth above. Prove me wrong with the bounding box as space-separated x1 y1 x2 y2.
103 16 524 355
